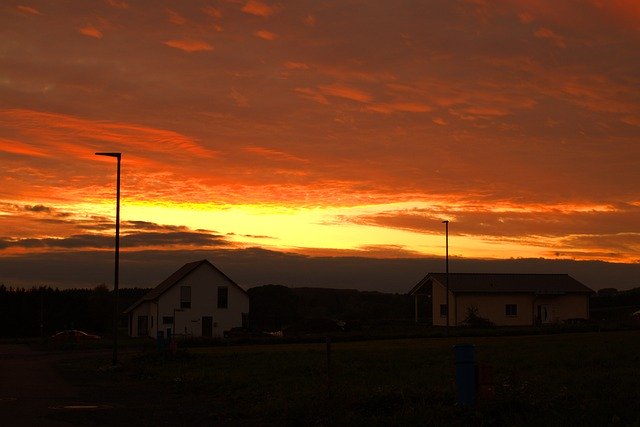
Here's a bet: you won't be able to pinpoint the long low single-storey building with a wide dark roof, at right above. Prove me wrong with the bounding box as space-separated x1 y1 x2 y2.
409 273 593 326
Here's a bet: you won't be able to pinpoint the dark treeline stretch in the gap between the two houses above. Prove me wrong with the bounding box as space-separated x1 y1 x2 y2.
247 285 414 333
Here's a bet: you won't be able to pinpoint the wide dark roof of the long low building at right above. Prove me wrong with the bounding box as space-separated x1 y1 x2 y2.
409 273 593 295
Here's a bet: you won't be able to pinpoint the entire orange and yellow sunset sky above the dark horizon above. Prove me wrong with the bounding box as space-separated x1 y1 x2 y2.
0 0 640 288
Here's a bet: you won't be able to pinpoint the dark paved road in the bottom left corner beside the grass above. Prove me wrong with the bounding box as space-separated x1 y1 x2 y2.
0 344 97 426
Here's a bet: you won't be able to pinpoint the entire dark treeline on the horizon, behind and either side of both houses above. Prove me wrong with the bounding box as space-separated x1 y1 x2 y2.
6 285 640 338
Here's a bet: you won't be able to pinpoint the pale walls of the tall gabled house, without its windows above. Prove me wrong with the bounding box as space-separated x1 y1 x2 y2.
130 263 249 338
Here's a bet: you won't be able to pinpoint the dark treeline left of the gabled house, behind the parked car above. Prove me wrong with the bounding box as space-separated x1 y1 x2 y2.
0 285 149 338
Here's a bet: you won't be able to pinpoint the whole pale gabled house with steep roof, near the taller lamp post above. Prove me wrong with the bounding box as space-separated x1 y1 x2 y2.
125 259 249 338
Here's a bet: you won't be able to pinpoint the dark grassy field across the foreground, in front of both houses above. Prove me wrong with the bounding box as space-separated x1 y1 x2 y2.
53 331 640 425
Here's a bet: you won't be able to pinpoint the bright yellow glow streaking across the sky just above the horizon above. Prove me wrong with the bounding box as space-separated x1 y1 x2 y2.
53 200 542 258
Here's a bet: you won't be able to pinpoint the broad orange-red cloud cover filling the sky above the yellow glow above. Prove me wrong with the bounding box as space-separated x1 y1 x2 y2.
0 0 640 268
